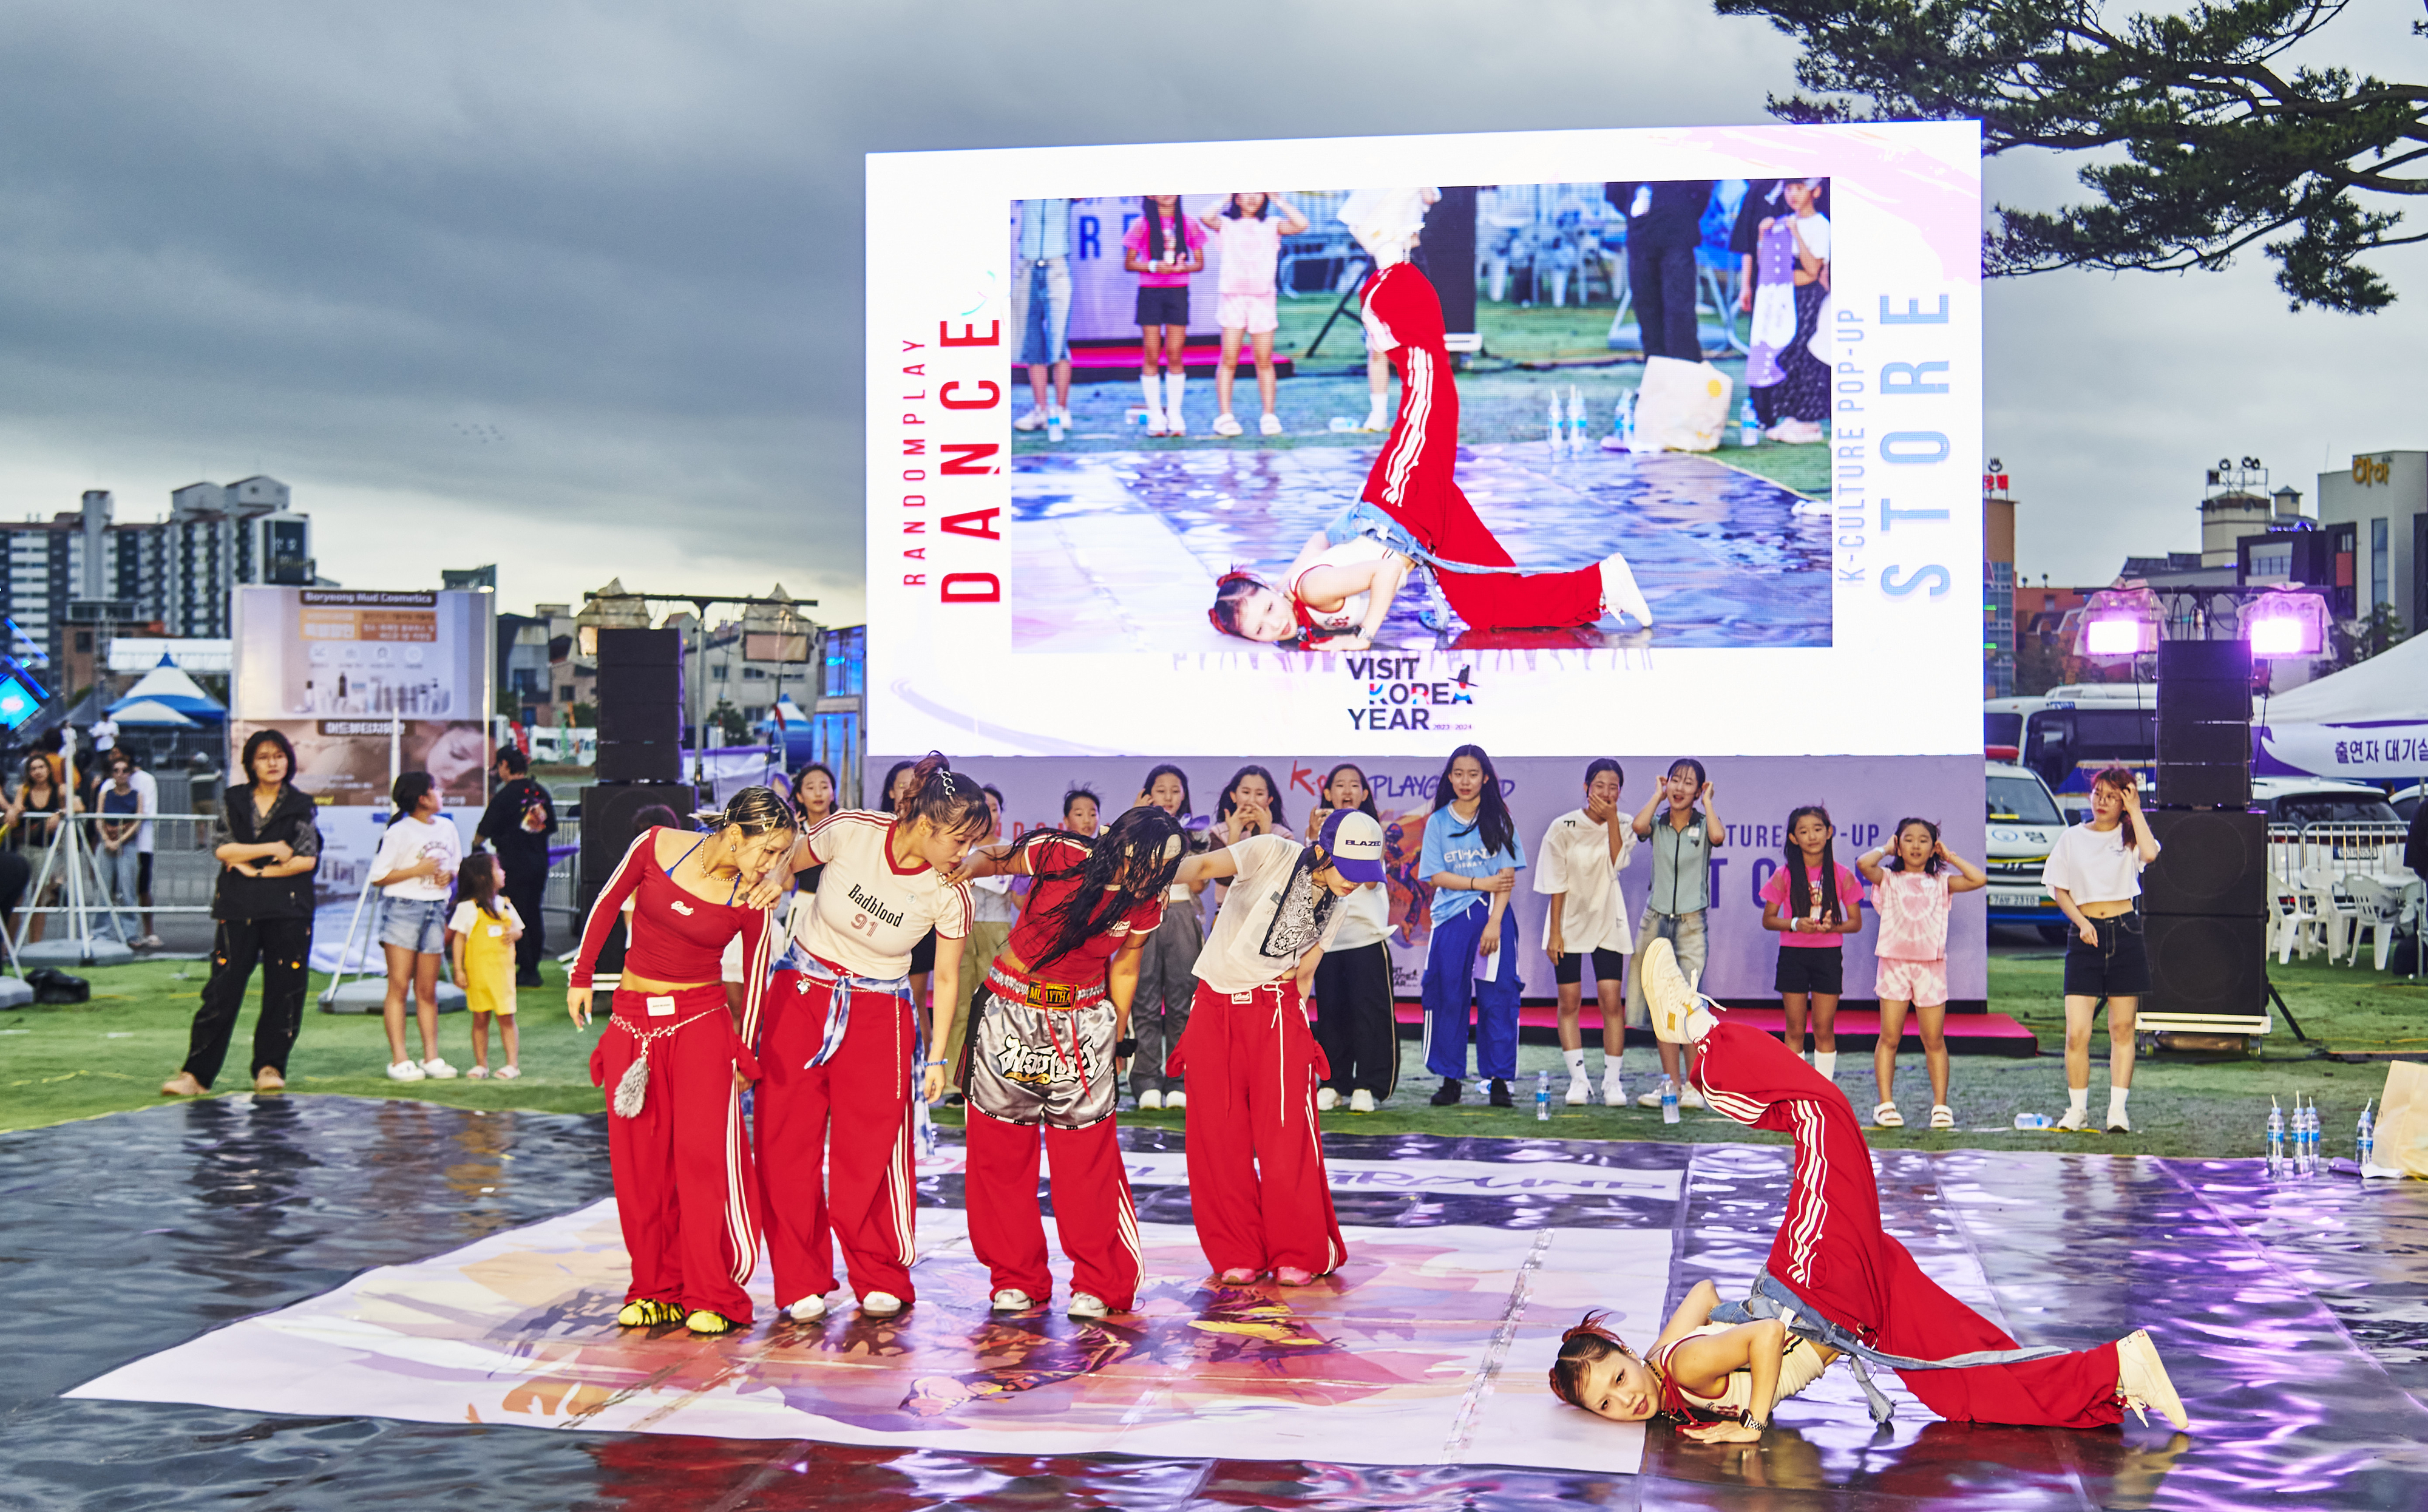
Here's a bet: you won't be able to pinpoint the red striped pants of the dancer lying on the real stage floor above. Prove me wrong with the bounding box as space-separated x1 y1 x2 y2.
1695 1022 2124 1427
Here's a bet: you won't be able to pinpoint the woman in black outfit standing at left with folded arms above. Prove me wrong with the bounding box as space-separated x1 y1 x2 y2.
160 731 320 1097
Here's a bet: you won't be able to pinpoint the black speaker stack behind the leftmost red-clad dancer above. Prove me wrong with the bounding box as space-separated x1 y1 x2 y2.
575 629 697 973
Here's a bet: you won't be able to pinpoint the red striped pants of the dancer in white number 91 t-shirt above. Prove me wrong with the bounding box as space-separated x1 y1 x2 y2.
758 971 918 1308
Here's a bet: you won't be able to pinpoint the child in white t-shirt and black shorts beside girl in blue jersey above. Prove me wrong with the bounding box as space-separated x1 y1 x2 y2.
1534 757 1636 1107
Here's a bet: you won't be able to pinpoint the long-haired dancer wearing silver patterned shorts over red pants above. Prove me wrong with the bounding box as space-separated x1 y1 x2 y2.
957 803 1185 1318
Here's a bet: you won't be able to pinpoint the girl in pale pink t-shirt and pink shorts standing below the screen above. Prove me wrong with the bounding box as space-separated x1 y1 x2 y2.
1855 818 1989 1128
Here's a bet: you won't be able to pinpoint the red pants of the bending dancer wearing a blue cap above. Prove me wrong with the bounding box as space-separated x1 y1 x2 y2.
1173 978 1348 1276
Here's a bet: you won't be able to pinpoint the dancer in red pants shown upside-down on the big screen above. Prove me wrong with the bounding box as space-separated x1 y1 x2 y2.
1212 189 1653 651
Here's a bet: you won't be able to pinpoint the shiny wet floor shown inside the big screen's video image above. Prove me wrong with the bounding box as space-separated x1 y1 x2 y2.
1008 444 1831 653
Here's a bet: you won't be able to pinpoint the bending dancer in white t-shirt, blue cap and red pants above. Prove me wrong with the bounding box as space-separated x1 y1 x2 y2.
1165 808 1384 1286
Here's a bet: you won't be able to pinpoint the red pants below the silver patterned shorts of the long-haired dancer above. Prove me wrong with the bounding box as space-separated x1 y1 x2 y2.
966 1111 1146 1313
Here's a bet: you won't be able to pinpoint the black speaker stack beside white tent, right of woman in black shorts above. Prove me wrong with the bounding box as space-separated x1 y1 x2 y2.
2139 641 2268 1043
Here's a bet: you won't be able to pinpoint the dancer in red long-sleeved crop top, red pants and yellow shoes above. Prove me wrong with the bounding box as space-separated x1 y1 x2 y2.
566 786 794 1332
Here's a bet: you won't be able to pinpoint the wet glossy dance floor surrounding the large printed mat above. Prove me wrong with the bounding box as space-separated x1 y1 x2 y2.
0 1097 2428 1510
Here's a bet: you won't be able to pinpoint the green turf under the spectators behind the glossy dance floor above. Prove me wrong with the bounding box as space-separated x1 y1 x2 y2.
14 951 2428 1155
